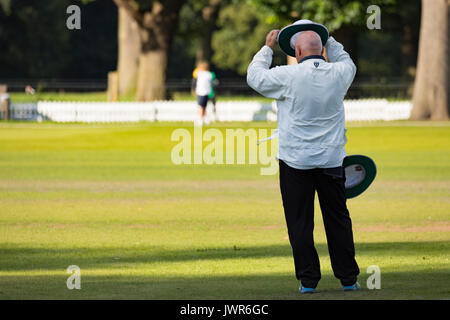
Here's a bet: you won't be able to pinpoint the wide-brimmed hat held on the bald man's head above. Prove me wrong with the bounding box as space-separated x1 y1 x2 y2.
278 19 329 57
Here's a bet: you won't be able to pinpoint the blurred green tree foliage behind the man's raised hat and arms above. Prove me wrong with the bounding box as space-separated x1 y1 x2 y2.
213 0 400 74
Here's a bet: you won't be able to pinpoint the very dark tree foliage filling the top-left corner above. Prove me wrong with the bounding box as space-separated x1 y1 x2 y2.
0 0 117 81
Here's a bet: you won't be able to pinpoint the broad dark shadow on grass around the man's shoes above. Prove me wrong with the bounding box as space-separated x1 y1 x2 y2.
0 270 450 300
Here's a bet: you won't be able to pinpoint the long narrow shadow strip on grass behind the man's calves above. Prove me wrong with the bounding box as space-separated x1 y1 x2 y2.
0 241 450 271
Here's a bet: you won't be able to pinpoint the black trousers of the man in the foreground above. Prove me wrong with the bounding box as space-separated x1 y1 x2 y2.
280 160 359 288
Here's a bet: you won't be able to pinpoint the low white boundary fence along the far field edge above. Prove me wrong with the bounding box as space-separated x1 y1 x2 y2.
7 99 412 122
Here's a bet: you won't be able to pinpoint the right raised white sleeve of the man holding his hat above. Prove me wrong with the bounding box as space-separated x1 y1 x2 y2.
325 37 356 90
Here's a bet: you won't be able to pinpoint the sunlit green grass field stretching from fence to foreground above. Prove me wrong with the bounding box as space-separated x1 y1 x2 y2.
0 122 450 299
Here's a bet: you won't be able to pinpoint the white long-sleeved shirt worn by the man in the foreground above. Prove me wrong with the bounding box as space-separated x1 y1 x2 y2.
247 37 356 169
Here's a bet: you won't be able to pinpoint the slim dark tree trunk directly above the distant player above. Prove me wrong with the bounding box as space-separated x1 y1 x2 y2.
196 0 222 64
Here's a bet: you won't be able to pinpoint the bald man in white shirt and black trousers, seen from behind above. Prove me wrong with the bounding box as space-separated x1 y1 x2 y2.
247 30 360 293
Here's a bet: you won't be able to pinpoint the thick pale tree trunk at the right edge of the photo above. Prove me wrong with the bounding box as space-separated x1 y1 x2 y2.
411 0 450 120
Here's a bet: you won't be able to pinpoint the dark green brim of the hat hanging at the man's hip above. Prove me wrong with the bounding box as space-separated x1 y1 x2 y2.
343 155 377 199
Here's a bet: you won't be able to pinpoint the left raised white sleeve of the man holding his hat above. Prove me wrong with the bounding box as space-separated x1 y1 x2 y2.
247 46 287 99
